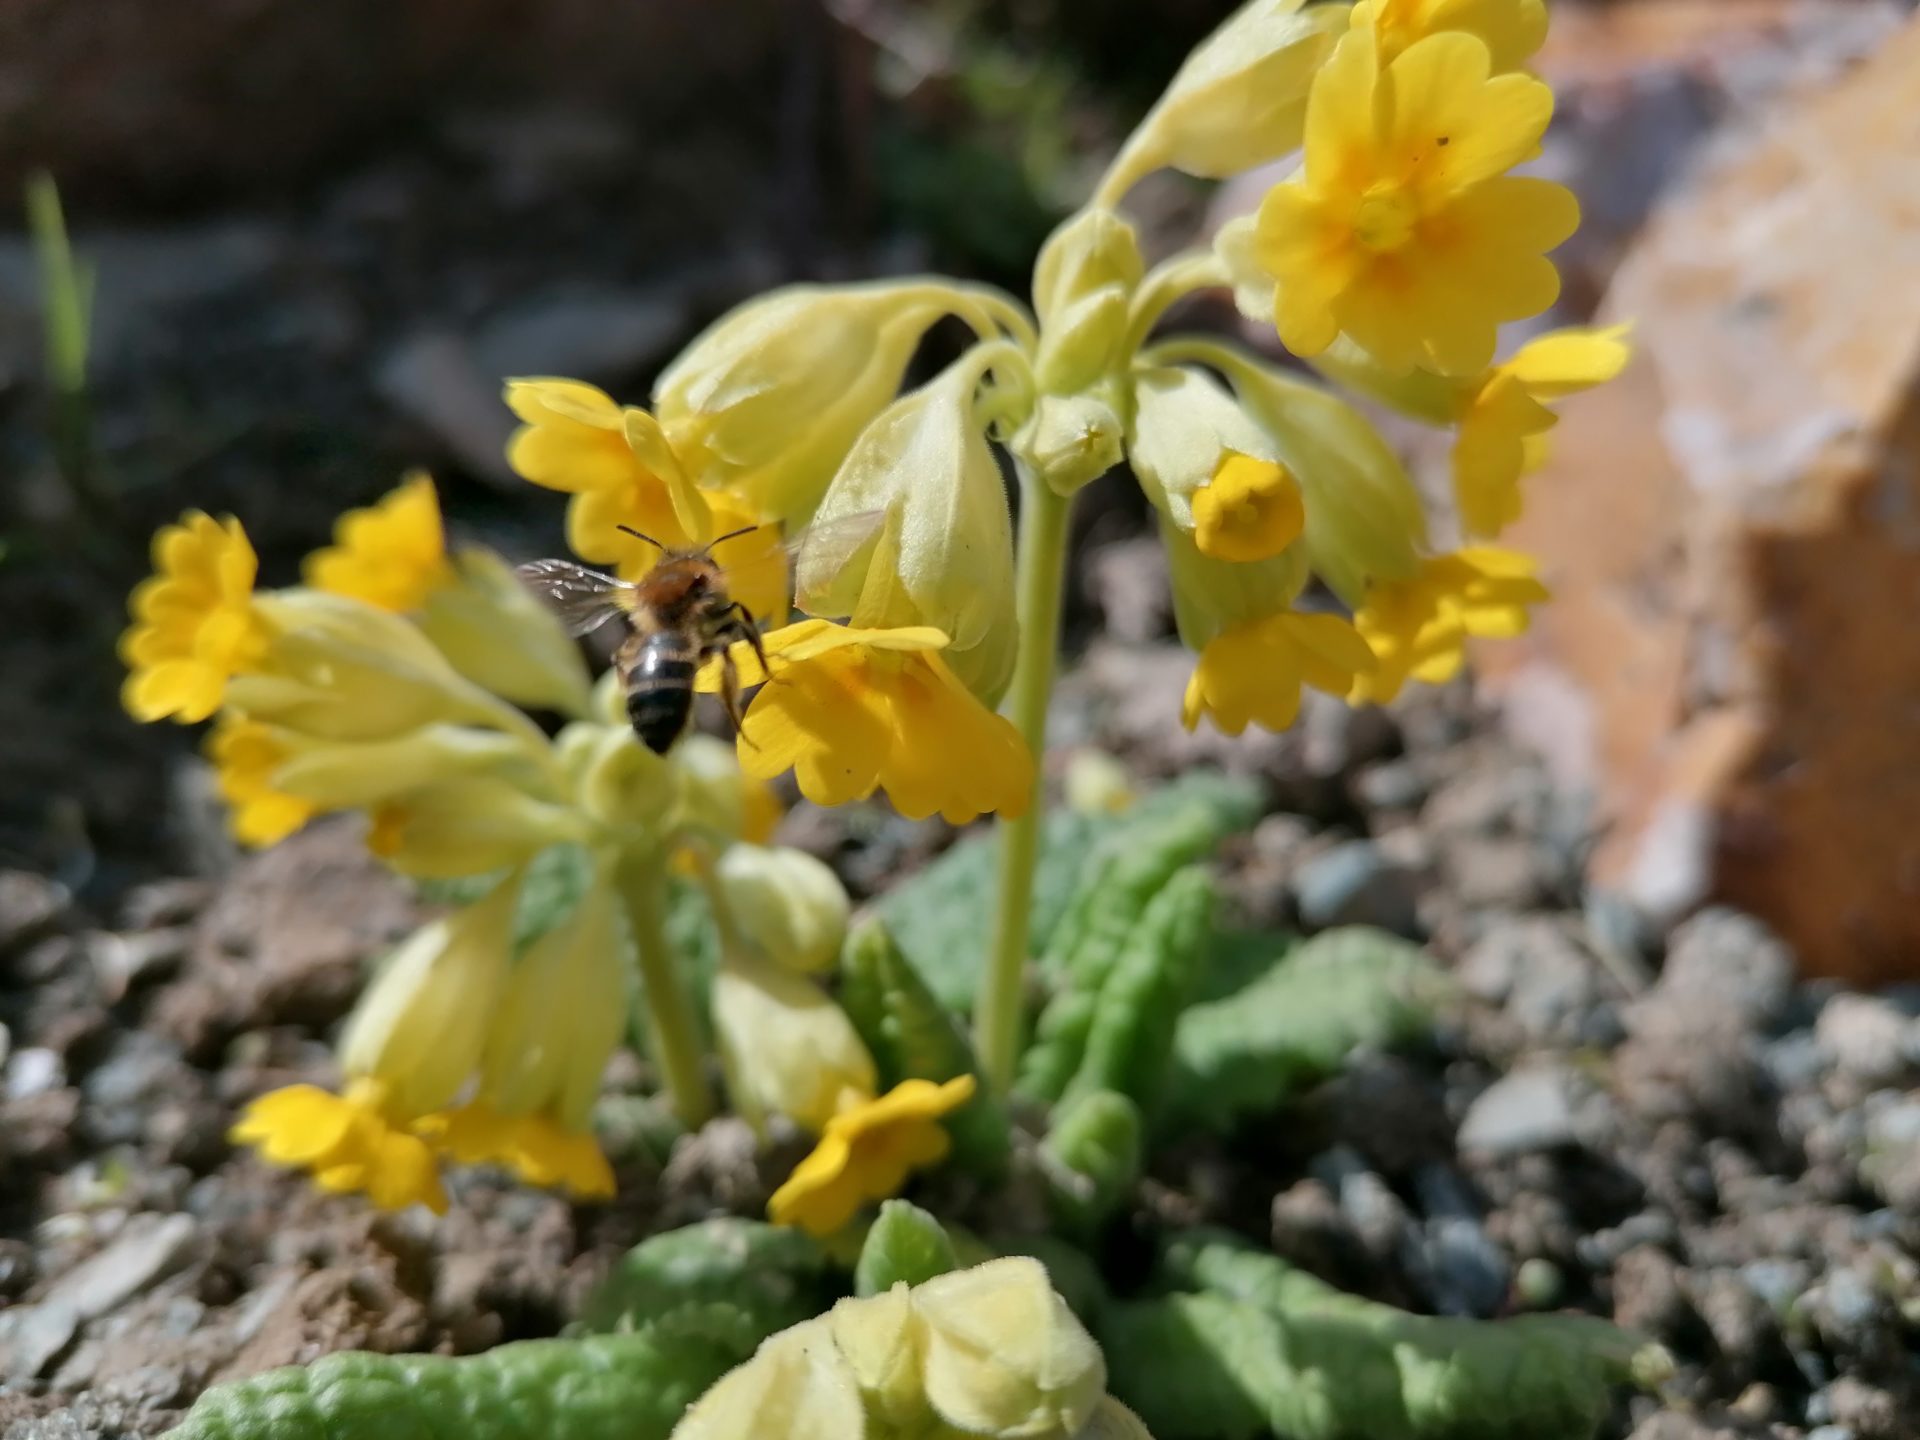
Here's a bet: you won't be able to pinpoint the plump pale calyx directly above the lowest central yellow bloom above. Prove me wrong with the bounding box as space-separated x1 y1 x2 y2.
712 952 879 1135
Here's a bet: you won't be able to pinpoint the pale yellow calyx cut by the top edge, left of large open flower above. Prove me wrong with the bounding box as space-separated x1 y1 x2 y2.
1098 0 1344 204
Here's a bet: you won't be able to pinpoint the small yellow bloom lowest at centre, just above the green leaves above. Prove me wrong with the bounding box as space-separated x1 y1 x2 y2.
766 1075 973 1236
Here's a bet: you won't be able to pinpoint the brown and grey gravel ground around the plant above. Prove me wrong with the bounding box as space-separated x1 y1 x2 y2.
0 645 1920 1440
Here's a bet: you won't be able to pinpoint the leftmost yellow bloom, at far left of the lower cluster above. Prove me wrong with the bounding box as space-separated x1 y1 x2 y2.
119 511 269 724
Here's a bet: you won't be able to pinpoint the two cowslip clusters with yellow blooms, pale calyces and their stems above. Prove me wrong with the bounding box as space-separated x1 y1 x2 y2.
125 0 1628 1231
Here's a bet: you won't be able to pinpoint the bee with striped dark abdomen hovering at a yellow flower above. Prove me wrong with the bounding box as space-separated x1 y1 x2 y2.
518 511 885 755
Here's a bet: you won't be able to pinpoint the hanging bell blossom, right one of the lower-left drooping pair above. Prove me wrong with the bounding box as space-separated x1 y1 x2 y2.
422 887 630 1200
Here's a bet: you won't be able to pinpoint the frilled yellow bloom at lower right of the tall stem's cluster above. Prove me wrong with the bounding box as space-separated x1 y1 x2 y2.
1352 545 1548 705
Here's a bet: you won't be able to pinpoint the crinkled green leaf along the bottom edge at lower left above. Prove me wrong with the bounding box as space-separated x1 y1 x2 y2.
169 1332 743 1440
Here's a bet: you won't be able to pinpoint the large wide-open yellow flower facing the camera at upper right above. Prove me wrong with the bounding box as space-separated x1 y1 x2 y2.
1256 29 1580 374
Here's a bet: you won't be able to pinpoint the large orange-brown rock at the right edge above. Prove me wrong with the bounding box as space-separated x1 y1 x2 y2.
1482 21 1920 981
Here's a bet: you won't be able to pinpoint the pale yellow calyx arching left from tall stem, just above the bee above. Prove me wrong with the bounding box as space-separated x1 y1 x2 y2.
653 278 987 522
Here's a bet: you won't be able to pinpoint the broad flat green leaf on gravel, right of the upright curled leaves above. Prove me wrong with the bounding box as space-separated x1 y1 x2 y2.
1162 925 1448 1129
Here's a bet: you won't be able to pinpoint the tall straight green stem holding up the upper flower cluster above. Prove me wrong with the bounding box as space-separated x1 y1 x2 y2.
973 467 1073 1094
